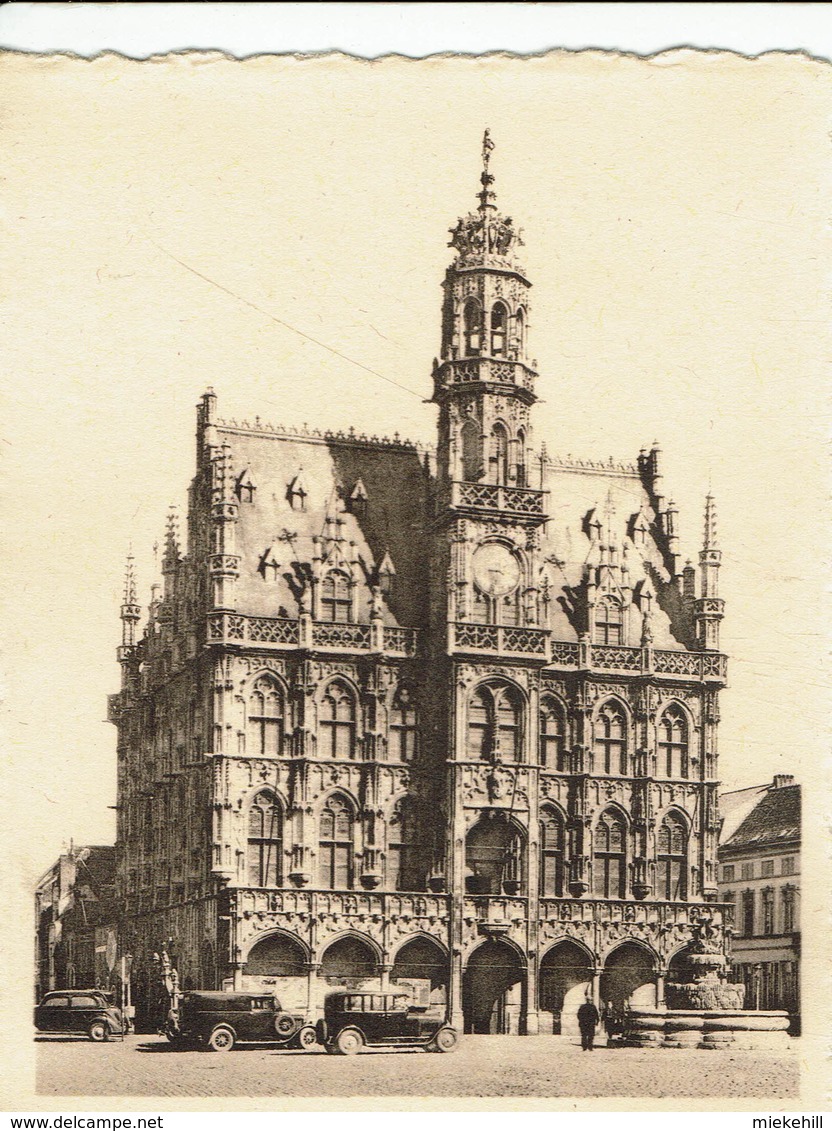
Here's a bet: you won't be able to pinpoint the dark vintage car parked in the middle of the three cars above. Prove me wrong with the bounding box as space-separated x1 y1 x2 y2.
165 990 315 1053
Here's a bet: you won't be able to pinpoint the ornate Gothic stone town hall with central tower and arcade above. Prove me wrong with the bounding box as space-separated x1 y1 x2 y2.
110 134 726 1033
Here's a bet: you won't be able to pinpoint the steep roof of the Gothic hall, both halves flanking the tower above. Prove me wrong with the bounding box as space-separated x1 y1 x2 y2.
211 422 686 649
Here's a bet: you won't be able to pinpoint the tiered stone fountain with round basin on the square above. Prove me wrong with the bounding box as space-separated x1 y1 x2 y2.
621 916 789 1048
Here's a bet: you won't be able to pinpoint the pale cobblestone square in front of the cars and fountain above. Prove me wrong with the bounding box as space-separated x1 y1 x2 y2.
37 1036 798 1100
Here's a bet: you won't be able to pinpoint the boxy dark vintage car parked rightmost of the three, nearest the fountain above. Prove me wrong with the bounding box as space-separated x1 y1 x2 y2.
317 993 458 1056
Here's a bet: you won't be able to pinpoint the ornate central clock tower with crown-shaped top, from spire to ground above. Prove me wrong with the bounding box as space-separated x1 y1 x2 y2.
431 130 549 1031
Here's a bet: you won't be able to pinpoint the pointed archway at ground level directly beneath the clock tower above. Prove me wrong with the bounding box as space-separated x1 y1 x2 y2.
462 939 526 1034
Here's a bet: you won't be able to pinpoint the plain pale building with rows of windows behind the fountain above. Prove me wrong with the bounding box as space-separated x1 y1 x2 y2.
719 774 800 1020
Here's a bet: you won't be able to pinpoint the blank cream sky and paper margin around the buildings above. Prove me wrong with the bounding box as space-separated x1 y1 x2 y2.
0 50 831 1110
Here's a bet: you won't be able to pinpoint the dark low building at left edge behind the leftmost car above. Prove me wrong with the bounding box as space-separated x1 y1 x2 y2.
35 845 118 1001
